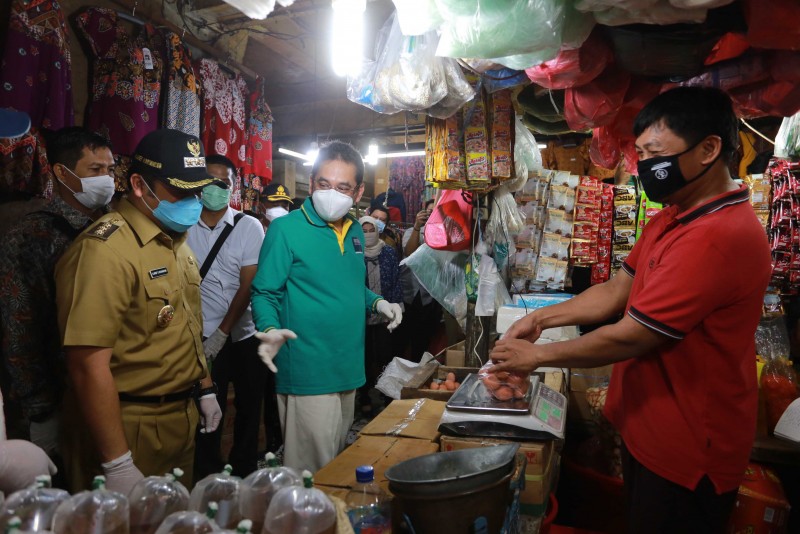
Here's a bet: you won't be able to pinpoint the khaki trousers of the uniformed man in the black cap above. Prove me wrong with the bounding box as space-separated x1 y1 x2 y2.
62 391 199 493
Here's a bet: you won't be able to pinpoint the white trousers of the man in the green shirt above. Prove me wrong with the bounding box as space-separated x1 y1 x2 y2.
278 389 356 473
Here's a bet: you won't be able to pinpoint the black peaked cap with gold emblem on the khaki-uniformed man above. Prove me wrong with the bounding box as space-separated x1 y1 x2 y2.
130 128 219 191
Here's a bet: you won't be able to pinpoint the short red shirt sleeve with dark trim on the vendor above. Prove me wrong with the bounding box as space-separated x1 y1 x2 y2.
628 236 733 339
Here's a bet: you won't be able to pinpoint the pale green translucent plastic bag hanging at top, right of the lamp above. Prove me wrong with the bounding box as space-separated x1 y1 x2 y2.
436 0 564 61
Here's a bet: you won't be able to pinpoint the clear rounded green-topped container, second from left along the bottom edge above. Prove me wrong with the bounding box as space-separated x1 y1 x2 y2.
53 476 130 534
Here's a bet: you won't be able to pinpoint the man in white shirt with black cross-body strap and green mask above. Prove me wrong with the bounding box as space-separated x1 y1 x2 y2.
187 155 267 480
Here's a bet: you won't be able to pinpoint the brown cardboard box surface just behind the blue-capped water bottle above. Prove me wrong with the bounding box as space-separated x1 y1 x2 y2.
314 435 439 491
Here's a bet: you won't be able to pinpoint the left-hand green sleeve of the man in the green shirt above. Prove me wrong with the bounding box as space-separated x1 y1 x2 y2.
250 220 292 332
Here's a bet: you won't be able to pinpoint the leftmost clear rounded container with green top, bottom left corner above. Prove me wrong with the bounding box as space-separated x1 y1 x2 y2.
0 475 69 532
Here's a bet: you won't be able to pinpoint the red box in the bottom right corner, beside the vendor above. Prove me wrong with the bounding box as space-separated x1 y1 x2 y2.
726 463 790 534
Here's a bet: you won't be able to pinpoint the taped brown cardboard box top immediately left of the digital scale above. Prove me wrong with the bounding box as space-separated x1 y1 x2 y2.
361 399 446 441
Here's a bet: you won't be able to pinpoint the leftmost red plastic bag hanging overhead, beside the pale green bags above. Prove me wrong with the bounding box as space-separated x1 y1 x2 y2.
525 32 614 89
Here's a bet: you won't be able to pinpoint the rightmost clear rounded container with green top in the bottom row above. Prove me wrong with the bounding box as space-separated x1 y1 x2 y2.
262 471 336 534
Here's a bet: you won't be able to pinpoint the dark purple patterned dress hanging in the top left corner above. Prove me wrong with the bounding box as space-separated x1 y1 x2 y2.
0 0 73 130
